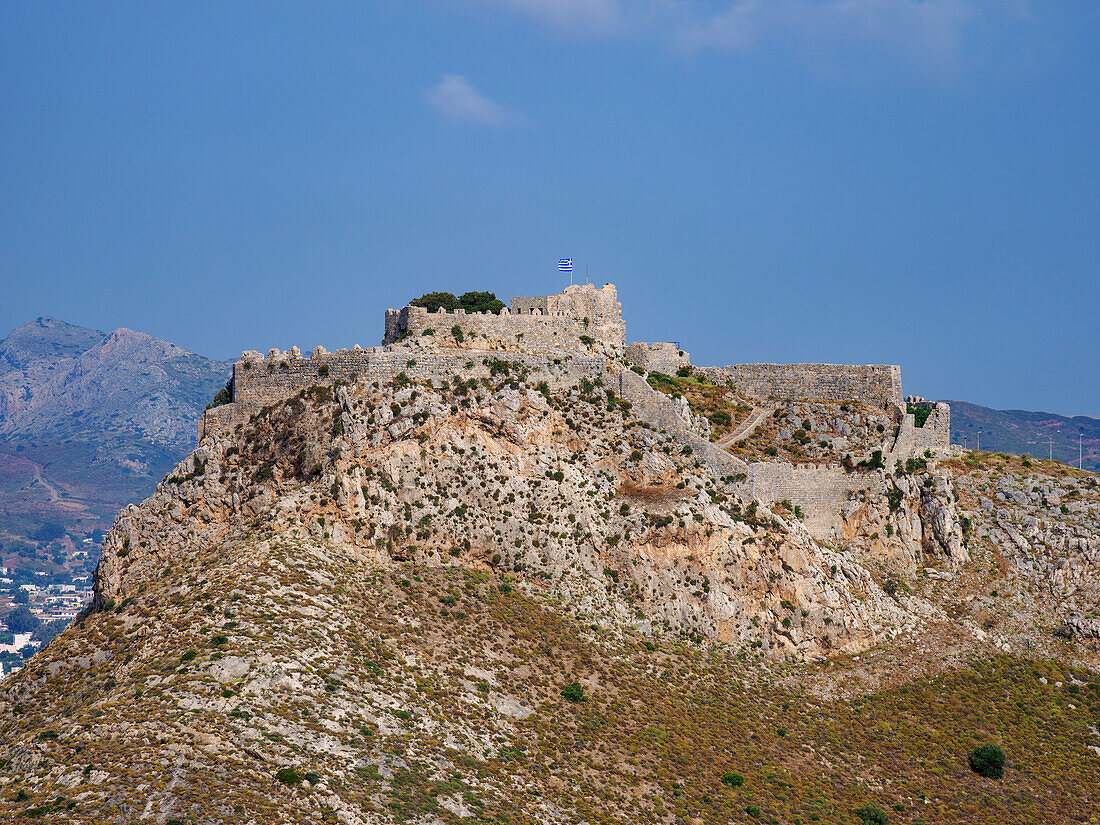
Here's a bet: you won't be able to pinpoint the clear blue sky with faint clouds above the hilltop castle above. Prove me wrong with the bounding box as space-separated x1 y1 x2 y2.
0 0 1100 415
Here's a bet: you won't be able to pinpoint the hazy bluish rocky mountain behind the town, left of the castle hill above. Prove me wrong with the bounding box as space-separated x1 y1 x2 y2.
0 318 229 563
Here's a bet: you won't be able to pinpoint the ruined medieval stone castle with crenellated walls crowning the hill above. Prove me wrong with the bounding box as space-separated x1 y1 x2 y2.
199 284 950 535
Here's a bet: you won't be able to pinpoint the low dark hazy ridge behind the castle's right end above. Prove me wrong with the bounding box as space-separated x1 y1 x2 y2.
947 402 1100 471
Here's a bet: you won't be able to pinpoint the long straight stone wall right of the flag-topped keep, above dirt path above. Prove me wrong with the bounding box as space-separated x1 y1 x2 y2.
696 364 902 409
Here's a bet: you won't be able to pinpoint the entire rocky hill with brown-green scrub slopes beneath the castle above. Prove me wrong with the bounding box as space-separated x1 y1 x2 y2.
0 288 1100 824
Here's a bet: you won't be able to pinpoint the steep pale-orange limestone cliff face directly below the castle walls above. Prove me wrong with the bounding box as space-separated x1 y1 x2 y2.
97 365 910 659
